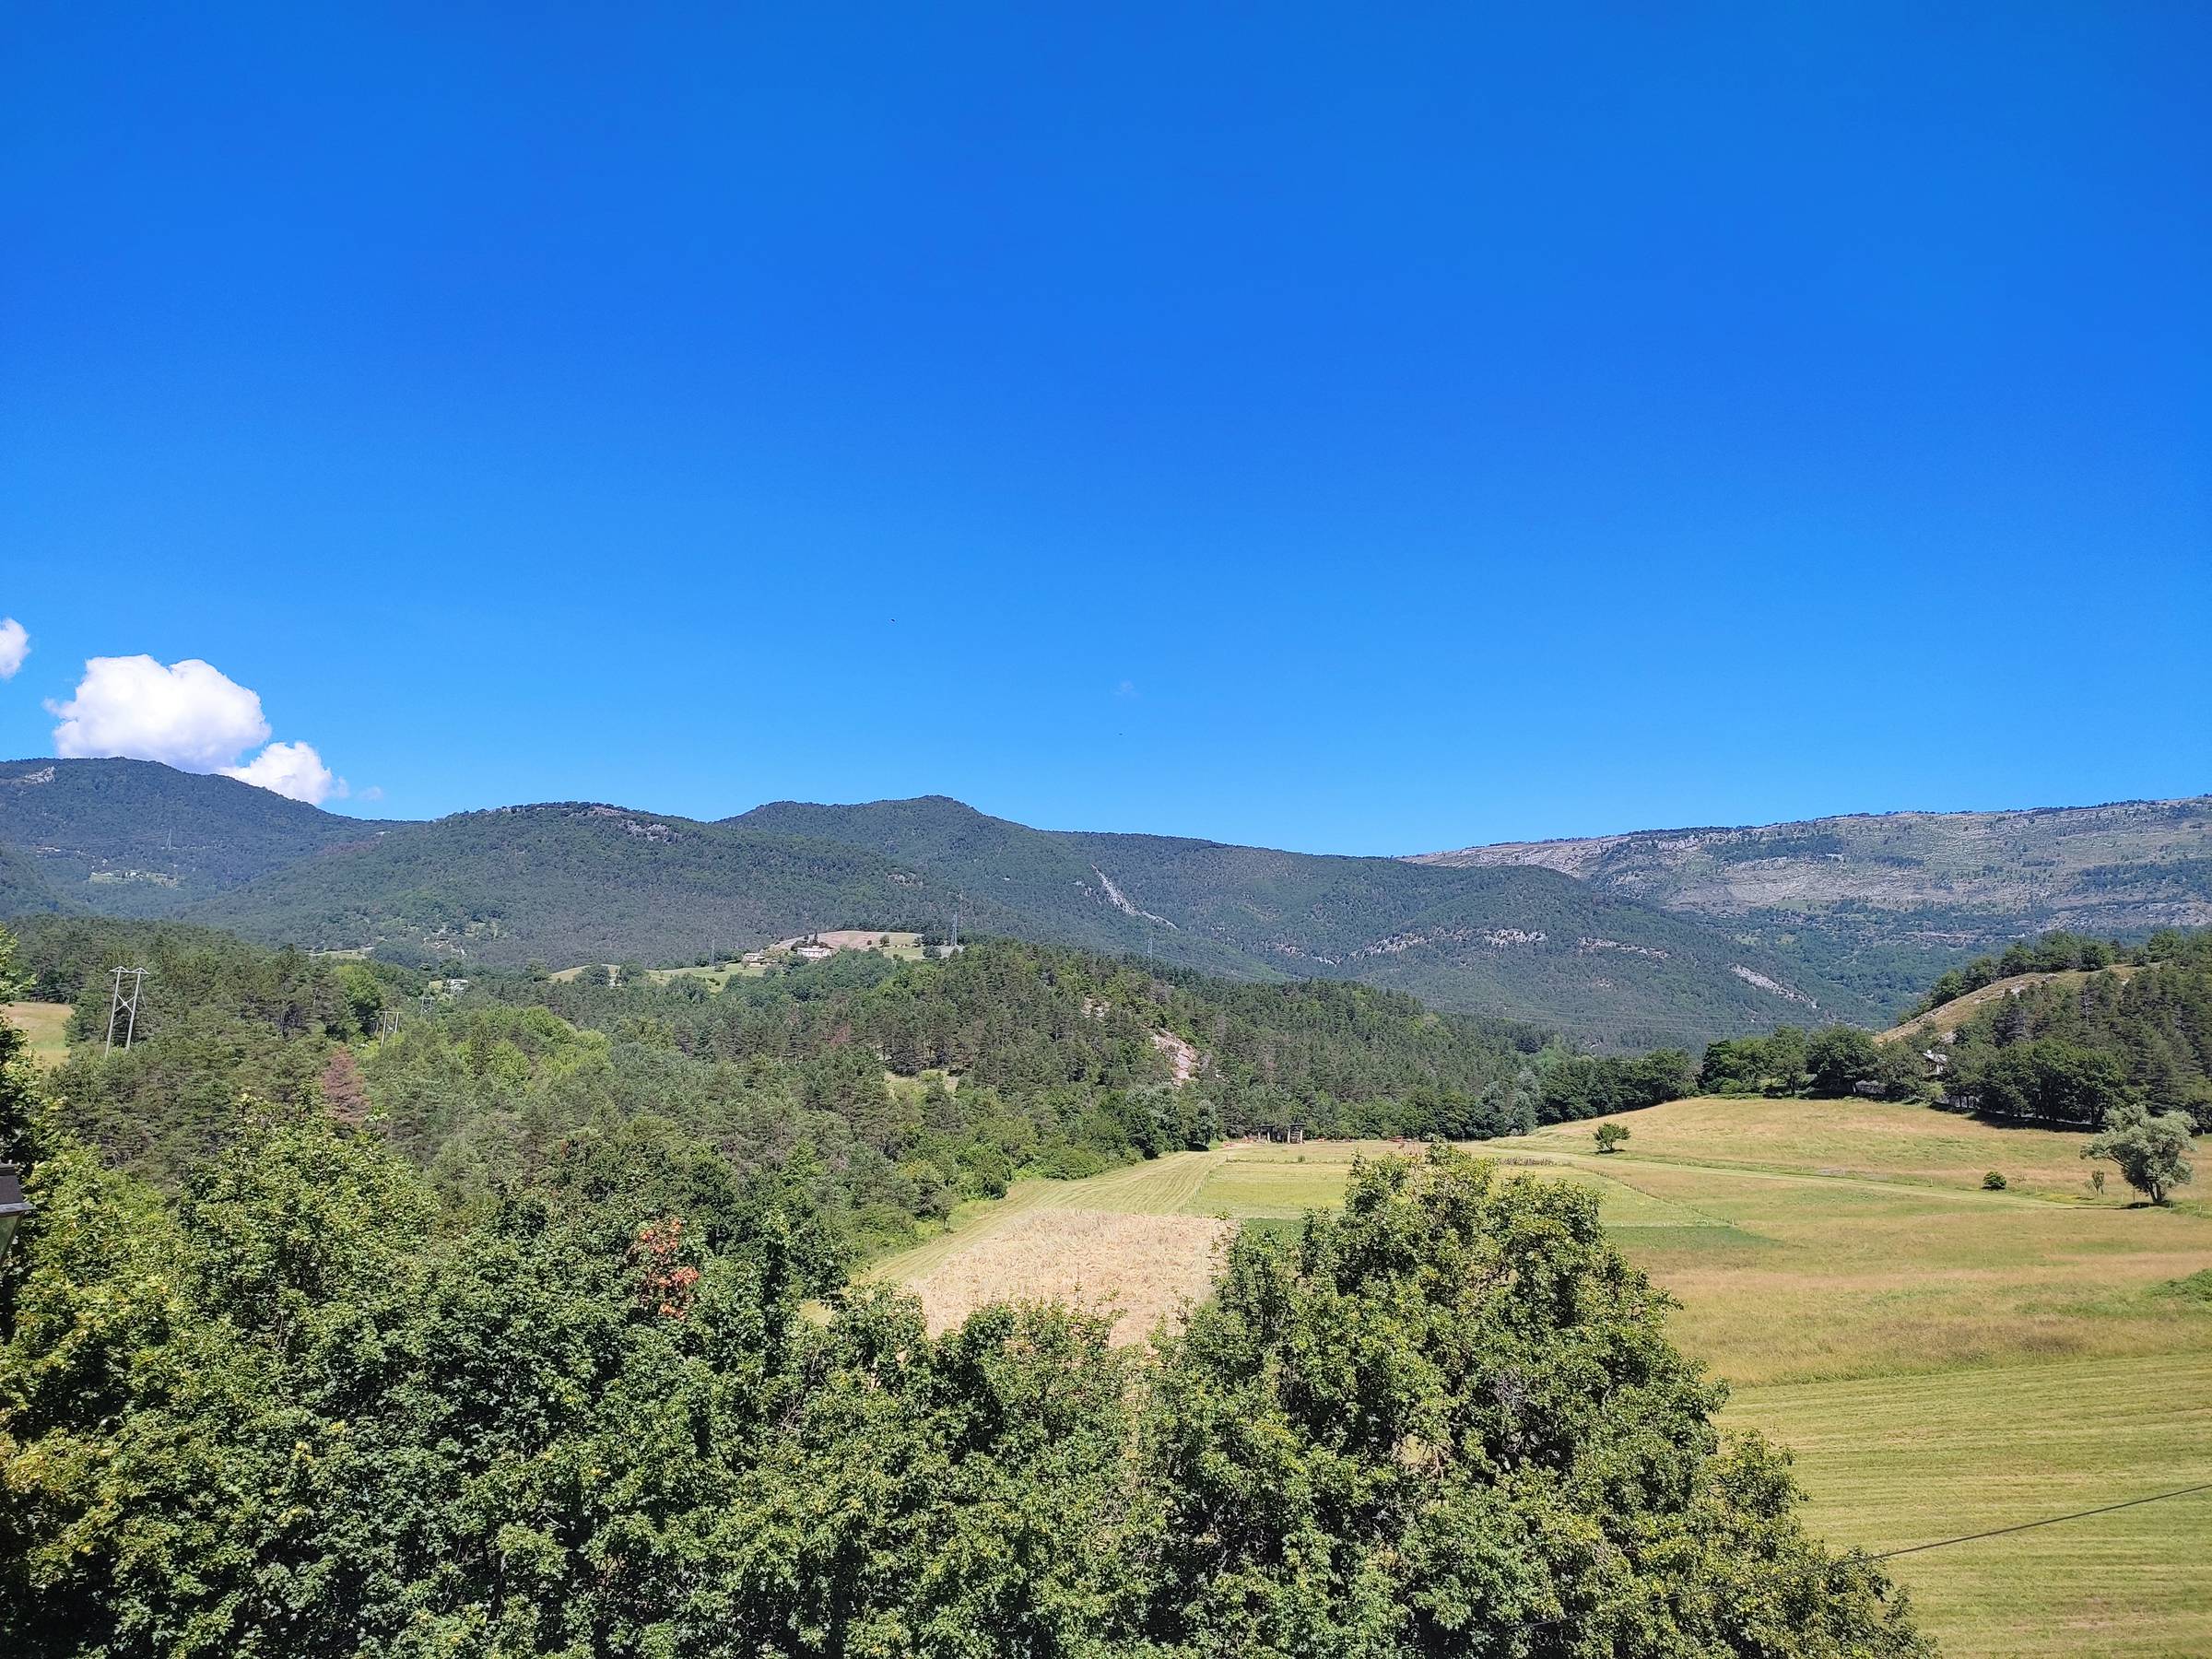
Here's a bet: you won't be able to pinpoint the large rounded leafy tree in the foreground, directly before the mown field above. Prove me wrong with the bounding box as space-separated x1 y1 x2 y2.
1146 1148 1926 1657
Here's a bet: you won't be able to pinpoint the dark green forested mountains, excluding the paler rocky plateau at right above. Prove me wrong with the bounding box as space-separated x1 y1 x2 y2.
0 761 1874 1051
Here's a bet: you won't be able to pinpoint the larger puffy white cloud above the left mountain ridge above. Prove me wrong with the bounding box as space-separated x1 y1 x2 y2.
46 657 345 803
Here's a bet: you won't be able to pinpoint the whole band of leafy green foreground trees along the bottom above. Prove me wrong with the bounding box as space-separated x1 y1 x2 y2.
0 1141 1924 1659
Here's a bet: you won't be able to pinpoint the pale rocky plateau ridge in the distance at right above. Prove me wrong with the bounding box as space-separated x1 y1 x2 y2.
1414 796 2212 1011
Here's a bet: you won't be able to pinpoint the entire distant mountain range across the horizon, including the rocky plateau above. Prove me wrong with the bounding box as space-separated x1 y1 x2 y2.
26 761 2212 1049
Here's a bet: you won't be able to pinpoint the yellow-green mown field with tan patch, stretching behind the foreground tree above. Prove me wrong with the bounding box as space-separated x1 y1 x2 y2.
878 1100 2212 1654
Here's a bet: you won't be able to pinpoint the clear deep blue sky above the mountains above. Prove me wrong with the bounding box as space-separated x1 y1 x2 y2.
0 0 2212 852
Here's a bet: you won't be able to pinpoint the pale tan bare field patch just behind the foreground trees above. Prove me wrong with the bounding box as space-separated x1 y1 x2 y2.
907 1210 1237 1343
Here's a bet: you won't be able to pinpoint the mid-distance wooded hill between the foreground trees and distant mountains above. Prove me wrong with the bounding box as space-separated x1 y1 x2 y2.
4 918 1694 1252
